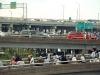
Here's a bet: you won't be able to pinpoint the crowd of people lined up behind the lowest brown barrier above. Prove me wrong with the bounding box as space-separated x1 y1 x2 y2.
3 48 100 65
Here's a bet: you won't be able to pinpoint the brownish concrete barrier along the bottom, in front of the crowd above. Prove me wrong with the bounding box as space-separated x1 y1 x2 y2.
0 63 100 75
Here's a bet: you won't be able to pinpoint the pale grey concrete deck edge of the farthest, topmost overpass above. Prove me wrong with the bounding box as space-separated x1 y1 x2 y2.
0 17 100 28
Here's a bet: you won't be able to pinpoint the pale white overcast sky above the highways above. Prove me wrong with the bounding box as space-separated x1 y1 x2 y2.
0 0 100 19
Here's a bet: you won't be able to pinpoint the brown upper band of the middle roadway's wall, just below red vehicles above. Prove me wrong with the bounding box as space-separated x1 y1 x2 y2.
0 36 100 45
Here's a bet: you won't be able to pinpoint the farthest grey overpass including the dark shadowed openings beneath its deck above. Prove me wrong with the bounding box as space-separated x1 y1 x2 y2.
0 17 100 34
